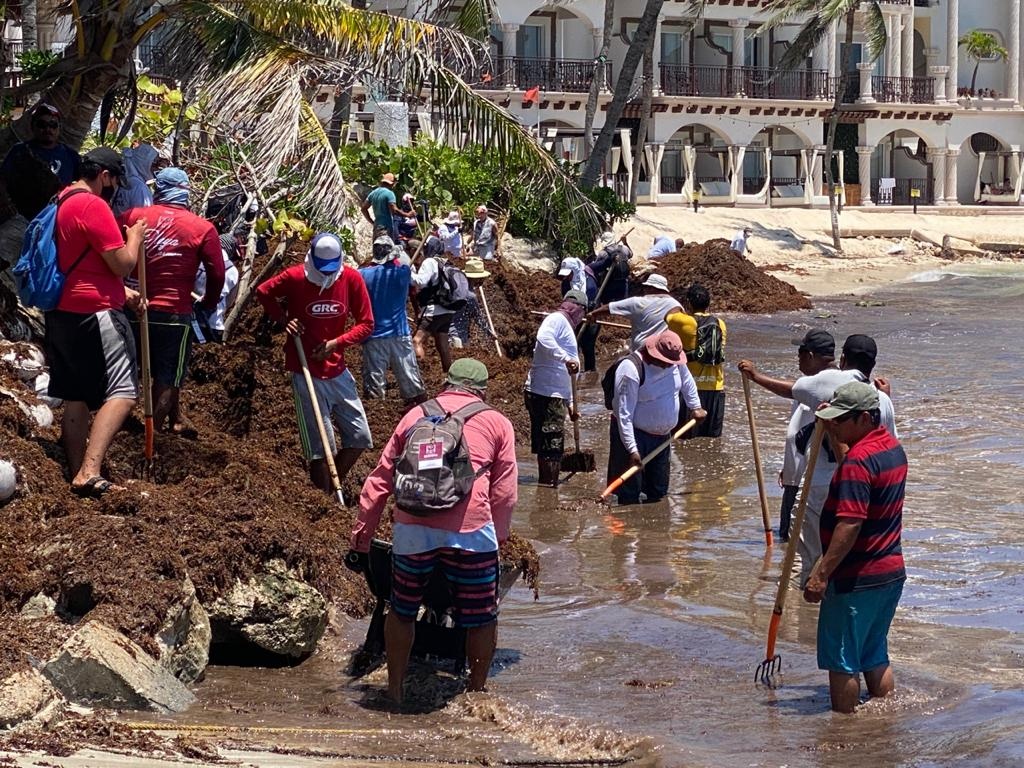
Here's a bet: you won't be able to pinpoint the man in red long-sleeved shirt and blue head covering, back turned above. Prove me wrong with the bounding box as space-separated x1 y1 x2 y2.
122 168 224 434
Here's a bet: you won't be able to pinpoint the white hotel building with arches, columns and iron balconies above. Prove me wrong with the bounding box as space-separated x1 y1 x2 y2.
357 0 1024 206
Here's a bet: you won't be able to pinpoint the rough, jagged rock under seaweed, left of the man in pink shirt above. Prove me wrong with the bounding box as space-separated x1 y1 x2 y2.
206 560 327 660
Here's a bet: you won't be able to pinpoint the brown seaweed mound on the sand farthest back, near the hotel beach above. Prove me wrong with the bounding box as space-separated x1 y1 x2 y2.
657 240 811 313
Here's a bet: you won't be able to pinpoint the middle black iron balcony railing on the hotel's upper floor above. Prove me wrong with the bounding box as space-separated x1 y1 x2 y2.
662 63 834 101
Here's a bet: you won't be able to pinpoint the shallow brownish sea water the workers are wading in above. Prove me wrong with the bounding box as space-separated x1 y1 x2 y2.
159 269 1024 768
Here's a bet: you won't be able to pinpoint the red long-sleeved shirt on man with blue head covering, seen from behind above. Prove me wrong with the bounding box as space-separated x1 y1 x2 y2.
120 203 224 314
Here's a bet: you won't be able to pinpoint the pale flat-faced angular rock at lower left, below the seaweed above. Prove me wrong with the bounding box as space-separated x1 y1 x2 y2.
43 622 196 713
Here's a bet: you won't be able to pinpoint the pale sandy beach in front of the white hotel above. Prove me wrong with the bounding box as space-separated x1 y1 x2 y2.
614 206 1024 296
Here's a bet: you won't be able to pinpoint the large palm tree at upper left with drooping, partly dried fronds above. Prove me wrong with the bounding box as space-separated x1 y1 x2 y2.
0 0 601 233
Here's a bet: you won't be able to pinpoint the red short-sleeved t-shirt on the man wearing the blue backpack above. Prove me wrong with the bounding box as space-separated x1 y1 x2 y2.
56 189 125 314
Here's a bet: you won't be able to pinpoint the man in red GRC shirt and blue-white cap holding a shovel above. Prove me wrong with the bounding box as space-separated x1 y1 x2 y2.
256 233 374 494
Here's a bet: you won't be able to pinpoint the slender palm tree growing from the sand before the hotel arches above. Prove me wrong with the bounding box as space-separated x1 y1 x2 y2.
762 0 888 253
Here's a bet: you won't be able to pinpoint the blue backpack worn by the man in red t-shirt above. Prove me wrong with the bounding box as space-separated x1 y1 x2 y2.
11 189 89 312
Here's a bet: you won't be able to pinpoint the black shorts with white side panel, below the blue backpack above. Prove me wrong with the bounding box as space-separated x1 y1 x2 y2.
45 309 138 411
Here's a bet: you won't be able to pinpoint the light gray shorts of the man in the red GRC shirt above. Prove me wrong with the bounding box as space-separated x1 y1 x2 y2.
292 369 374 461
